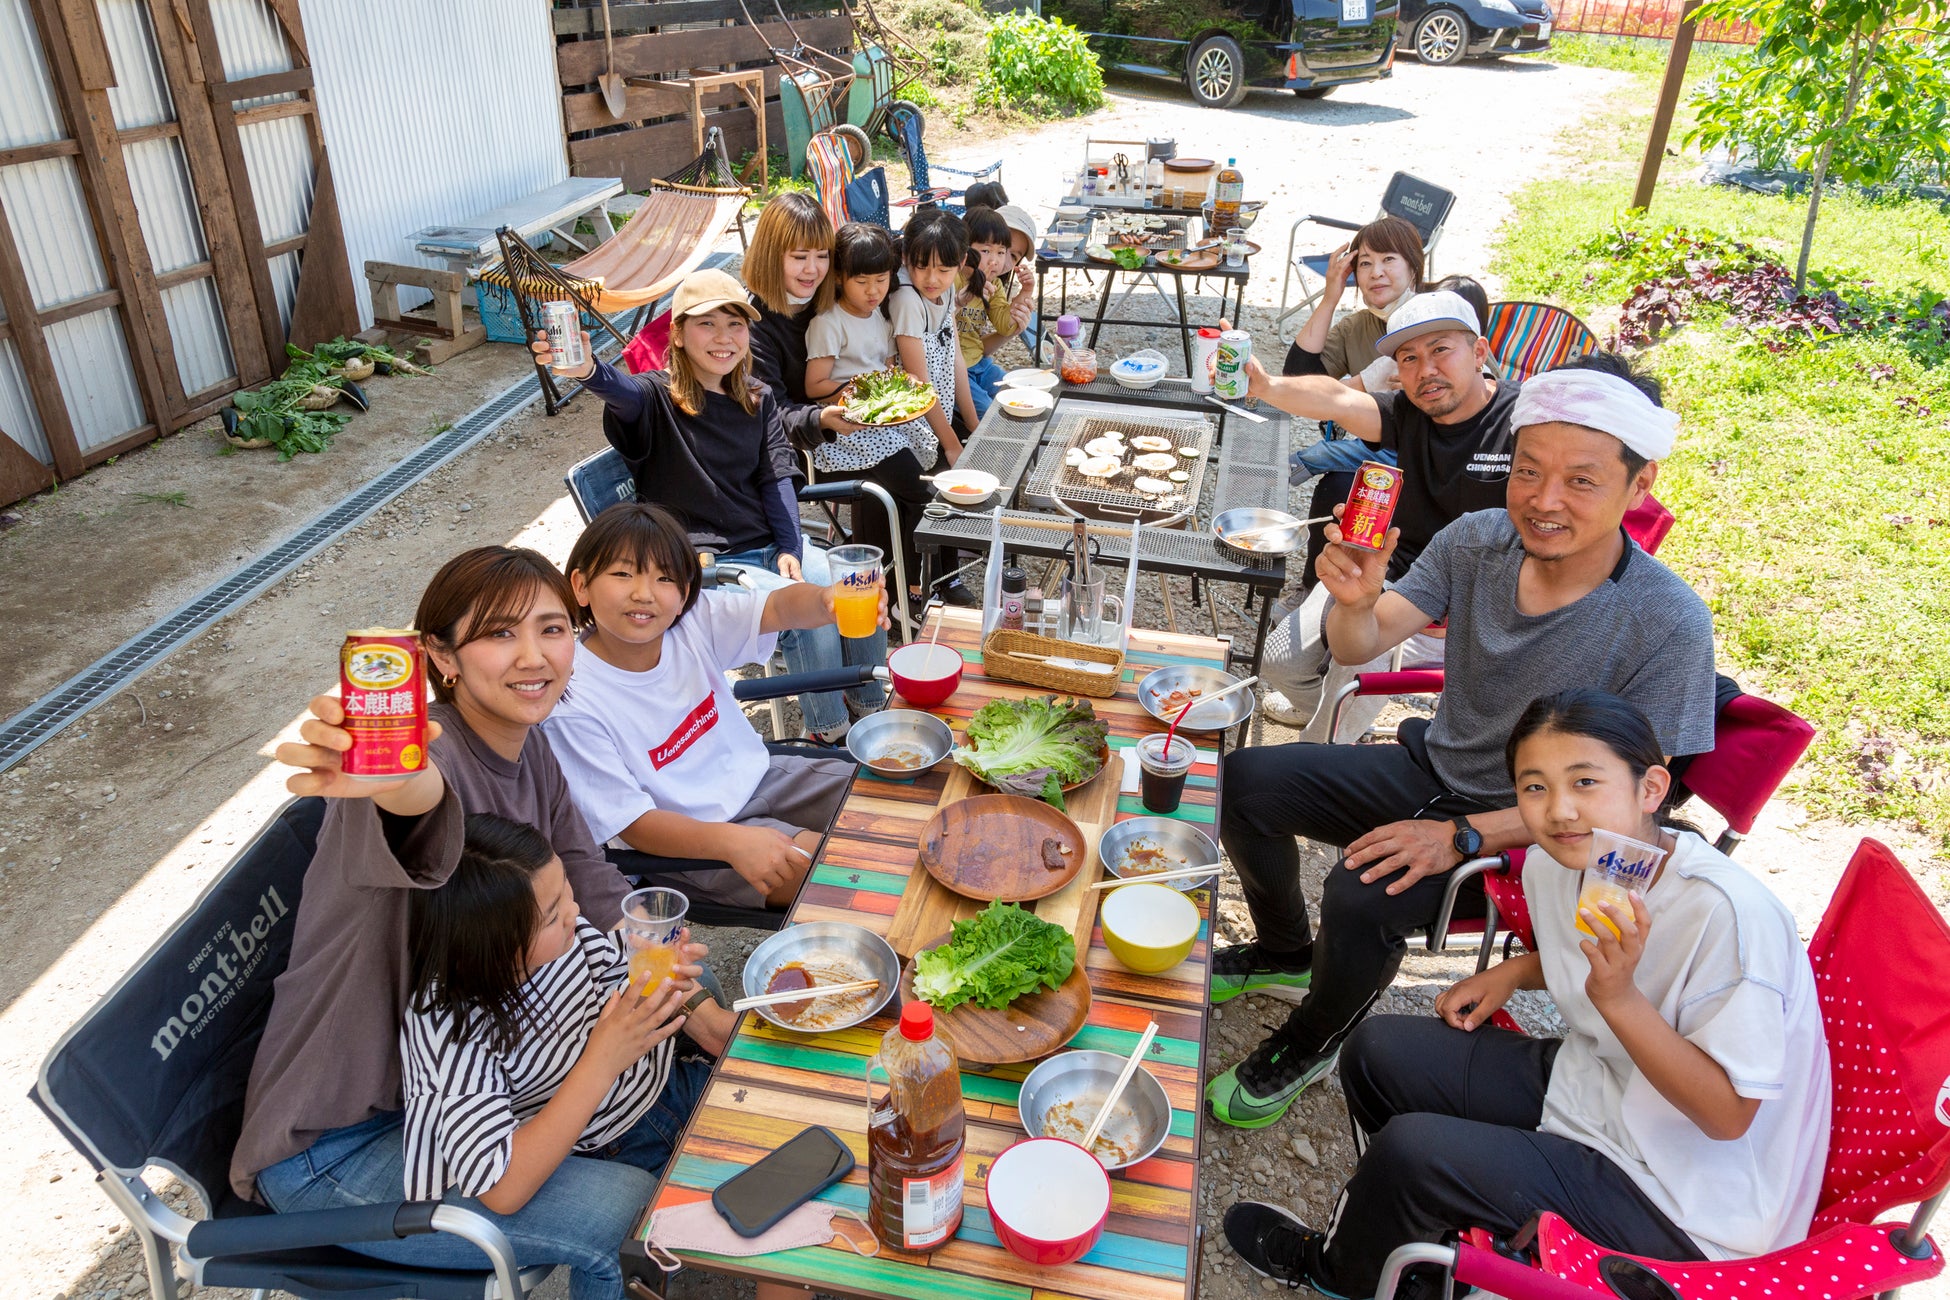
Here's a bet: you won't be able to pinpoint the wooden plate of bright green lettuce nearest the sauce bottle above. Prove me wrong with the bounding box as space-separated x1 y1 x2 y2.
901 902 1090 1066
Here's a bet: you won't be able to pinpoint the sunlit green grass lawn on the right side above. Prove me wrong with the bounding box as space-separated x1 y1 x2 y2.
1492 48 1950 848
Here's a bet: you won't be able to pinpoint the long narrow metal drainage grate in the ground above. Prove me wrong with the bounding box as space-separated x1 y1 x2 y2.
0 374 565 772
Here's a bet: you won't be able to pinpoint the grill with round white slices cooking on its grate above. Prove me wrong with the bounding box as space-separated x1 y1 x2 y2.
1024 401 1213 528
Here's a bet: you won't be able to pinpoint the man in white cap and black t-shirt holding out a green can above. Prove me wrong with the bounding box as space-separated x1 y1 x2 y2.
1248 290 1517 741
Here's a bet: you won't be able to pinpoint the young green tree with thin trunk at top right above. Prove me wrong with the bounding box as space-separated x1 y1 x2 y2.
1687 0 1950 292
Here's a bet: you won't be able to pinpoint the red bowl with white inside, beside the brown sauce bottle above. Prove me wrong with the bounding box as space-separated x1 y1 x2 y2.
985 1138 1110 1267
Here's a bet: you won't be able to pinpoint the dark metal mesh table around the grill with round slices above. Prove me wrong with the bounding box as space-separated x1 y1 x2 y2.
915 380 1293 672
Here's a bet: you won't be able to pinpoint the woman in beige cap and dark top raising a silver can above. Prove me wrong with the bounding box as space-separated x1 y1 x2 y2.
532 271 887 745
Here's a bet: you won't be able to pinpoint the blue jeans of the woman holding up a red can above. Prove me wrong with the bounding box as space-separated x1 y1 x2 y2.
257 1056 712 1300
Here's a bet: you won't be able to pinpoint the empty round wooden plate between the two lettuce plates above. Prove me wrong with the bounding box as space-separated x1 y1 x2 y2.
920 795 1090 902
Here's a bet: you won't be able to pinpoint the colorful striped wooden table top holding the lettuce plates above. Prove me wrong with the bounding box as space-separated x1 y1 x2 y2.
651 610 1227 1300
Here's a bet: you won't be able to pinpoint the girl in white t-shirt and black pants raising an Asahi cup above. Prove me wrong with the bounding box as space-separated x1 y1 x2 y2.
1225 690 1829 1296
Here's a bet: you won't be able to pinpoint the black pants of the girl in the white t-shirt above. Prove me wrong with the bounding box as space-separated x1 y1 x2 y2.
1320 1015 1702 1296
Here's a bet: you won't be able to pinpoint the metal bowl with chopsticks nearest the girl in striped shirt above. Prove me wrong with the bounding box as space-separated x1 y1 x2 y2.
741 920 901 1033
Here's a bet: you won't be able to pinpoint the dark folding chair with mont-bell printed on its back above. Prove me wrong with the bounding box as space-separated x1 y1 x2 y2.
31 799 548 1300
